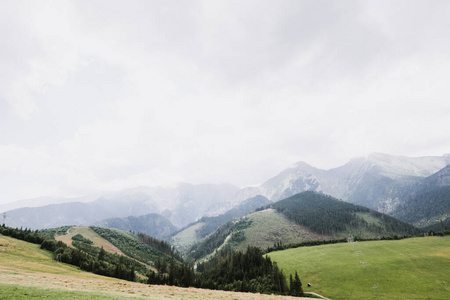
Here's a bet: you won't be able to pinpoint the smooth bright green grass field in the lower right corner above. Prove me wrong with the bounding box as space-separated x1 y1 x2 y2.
269 236 450 300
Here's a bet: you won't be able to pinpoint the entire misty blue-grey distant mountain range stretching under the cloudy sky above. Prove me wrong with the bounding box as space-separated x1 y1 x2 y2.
0 153 450 229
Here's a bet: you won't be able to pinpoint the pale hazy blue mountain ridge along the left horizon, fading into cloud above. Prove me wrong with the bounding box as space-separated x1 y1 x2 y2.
4 183 239 229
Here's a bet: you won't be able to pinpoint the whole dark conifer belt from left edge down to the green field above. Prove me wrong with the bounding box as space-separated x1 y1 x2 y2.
0 224 303 296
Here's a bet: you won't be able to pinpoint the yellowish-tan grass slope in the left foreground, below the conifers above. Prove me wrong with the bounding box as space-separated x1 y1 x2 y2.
0 235 306 300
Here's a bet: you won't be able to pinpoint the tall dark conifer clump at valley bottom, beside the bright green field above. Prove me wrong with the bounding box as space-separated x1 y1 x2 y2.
148 246 303 296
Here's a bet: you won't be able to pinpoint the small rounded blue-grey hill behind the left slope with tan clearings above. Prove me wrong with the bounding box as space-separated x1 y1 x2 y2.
95 214 177 239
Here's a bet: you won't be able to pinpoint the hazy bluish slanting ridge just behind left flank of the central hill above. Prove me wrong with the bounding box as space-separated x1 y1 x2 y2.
170 195 270 252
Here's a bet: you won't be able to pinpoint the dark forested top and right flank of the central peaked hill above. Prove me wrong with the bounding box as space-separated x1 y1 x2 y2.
271 191 418 236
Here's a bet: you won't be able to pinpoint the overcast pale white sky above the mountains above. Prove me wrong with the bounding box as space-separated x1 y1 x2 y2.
0 0 450 203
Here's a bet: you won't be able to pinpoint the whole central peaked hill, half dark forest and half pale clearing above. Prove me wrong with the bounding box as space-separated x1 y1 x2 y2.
188 192 419 260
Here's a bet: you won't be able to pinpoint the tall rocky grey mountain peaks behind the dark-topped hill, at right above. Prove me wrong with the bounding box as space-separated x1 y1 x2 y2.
208 153 450 215
